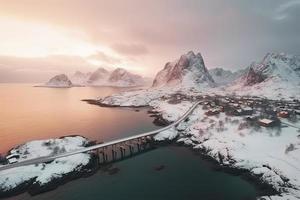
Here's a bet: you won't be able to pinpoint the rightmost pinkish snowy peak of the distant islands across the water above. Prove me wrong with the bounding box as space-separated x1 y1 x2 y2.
107 68 145 86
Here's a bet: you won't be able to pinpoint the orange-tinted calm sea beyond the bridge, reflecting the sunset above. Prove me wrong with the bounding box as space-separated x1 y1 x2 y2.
0 84 157 153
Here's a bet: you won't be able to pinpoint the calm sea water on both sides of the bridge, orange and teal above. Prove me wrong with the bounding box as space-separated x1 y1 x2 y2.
0 84 259 200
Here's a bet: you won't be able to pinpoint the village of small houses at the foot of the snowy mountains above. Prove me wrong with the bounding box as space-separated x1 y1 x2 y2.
162 93 300 130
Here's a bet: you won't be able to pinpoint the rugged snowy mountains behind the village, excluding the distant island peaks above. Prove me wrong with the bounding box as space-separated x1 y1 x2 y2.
152 52 300 98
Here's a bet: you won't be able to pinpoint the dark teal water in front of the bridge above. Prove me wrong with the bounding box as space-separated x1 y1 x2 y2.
11 146 257 200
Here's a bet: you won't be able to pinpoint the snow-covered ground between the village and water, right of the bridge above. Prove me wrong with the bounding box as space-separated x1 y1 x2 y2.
100 88 300 200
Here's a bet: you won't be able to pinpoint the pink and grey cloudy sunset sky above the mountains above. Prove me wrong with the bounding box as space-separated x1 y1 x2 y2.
0 0 300 82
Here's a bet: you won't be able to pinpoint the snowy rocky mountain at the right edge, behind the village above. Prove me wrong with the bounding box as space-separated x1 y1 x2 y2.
228 53 300 98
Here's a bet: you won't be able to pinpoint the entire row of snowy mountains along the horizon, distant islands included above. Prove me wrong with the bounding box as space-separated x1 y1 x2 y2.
46 51 300 97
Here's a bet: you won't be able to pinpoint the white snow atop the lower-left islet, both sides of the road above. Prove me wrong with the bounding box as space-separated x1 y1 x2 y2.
0 136 91 191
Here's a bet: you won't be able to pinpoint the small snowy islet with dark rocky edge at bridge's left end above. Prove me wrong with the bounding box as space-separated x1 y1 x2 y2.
0 135 97 198
